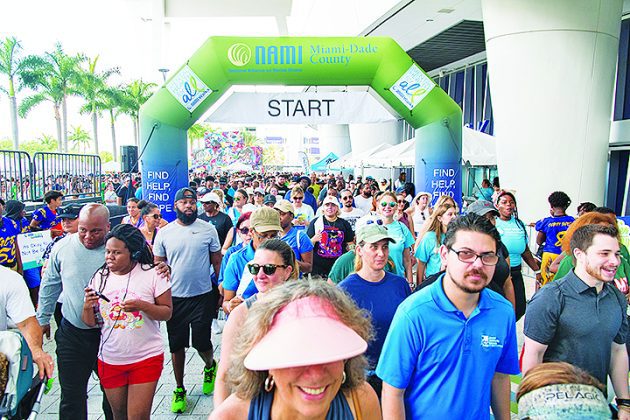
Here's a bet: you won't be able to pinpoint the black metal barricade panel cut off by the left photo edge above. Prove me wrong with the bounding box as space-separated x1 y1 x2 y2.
0 150 33 201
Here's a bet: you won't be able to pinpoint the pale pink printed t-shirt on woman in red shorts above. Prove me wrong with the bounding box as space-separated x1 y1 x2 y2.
90 264 171 365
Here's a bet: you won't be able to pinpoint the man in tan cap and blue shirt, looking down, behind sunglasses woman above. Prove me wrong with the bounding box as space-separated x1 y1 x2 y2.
221 206 282 314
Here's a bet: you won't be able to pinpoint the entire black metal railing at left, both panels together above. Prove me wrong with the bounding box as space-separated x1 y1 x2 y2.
0 150 102 202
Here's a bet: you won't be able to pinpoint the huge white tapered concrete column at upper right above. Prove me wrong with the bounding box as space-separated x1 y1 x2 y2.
482 0 622 222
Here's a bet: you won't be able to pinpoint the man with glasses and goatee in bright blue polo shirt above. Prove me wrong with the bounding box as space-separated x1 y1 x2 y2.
376 214 519 419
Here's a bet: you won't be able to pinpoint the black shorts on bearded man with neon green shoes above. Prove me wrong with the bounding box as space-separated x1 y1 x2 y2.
166 292 217 353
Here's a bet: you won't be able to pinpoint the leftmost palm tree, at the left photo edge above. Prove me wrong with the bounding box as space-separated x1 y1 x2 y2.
0 37 31 150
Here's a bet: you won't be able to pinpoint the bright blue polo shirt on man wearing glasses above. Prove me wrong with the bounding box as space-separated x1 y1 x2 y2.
376 275 519 419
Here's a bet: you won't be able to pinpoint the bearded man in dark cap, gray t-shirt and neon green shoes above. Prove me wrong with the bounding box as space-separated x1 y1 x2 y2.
153 188 221 413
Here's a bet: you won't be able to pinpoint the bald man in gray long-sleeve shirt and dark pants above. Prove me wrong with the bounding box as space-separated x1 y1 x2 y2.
37 204 113 419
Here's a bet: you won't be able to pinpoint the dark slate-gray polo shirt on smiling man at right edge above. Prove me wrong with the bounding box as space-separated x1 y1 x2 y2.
523 270 628 384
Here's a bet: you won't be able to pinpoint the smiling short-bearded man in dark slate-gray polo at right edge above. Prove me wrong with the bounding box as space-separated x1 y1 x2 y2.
523 225 630 419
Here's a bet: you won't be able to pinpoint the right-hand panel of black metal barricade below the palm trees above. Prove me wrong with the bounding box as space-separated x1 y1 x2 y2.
32 152 103 200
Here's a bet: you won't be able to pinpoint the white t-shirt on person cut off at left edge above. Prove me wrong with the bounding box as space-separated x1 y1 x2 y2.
0 265 35 331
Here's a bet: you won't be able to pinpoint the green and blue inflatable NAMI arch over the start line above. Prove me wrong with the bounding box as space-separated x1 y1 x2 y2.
140 37 461 220
